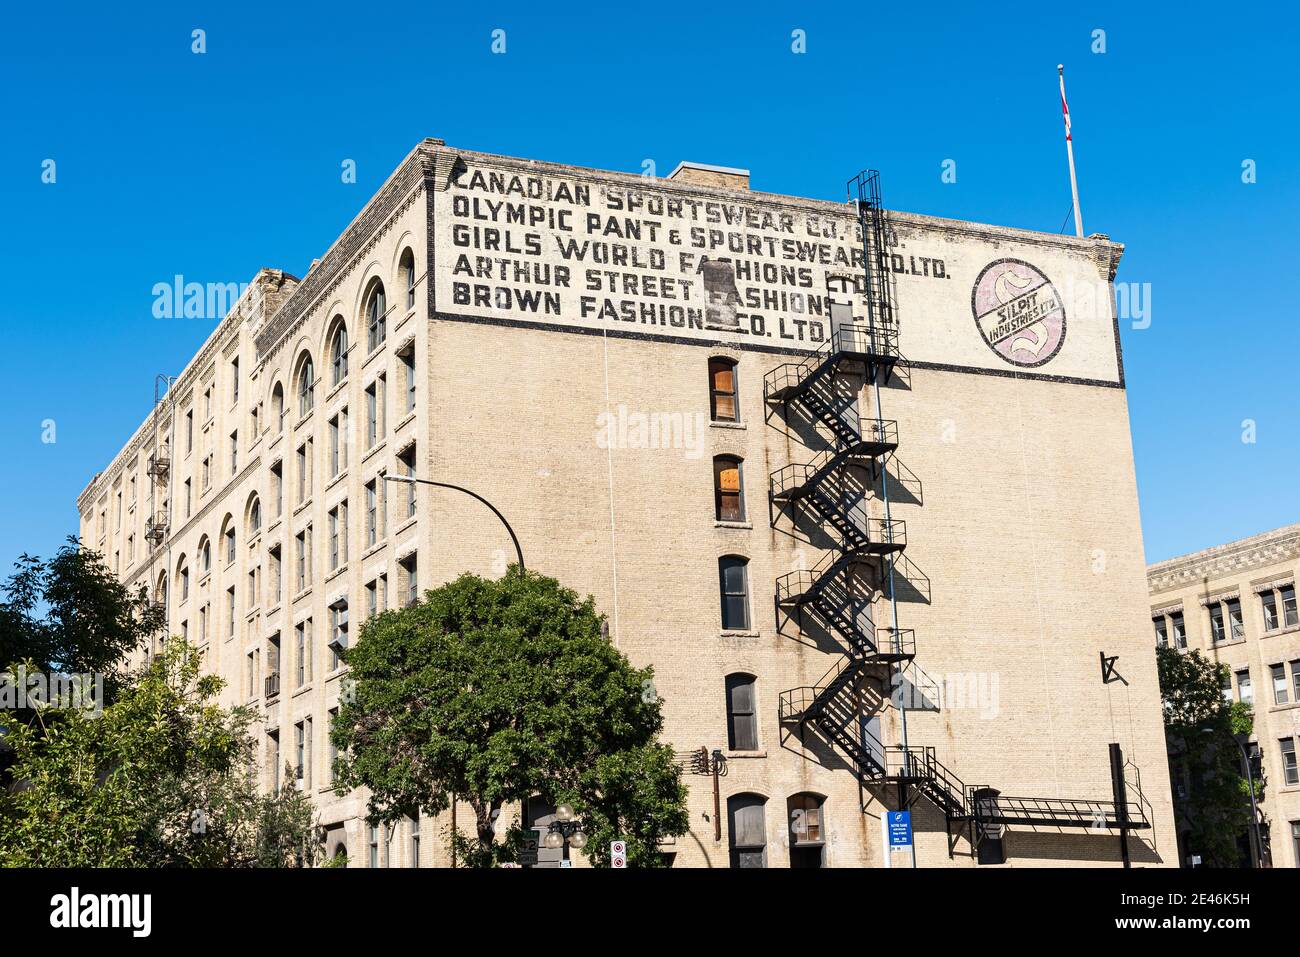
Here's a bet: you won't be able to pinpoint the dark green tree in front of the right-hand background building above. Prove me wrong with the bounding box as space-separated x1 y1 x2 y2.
1156 648 1264 867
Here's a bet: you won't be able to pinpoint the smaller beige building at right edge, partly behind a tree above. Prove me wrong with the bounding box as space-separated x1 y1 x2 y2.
1147 524 1300 867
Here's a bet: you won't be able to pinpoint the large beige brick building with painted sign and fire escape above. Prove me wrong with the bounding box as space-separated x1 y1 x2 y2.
78 139 1177 867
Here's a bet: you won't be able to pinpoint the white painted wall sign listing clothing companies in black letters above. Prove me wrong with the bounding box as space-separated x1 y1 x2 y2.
433 155 1118 382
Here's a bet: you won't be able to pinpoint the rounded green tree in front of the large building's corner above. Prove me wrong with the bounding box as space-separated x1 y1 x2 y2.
332 566 688 866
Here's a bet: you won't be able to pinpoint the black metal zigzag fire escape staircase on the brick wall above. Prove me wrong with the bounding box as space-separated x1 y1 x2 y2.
763 170 1152 857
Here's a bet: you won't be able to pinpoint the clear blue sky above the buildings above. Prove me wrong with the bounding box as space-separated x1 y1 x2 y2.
0 3 1300 570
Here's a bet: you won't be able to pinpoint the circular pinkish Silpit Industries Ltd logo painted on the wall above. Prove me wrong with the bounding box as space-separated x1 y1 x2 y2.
971 259 1065 367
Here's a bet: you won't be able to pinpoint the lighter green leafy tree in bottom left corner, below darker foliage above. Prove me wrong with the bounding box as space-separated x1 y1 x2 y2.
0 640 317 867
